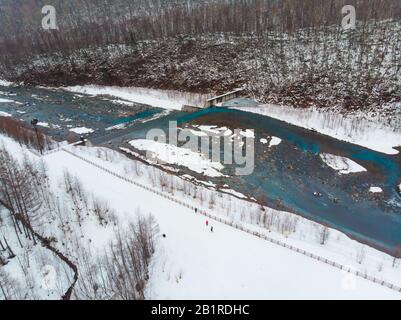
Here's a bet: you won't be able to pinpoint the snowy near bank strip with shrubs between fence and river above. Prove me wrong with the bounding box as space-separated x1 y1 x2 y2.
58 147 401 285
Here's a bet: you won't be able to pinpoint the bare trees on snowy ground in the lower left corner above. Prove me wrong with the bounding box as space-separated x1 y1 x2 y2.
0 146 158 300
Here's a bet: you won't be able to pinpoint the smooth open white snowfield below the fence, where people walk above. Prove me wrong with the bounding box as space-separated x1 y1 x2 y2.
46 152 401 299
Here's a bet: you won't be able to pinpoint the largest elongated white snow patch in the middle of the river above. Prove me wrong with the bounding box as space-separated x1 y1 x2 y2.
130 139 224 177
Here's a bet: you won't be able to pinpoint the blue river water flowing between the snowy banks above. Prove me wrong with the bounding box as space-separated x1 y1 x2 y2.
0 87 401 253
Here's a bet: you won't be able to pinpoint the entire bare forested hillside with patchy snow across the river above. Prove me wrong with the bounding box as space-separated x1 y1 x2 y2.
0 0 401 114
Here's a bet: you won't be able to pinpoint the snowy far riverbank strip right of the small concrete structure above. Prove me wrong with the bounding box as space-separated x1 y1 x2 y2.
235 104 401 154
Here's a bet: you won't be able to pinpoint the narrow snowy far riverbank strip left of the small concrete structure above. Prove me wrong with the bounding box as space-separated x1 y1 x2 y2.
62 85 209 110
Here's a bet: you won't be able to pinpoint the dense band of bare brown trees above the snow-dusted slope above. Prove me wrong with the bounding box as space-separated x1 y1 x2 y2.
0 0 401 63
